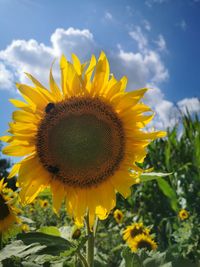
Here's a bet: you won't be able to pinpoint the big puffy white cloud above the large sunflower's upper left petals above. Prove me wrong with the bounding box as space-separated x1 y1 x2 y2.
0 28 96 86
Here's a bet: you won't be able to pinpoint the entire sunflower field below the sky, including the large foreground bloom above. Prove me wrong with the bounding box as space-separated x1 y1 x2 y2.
0 52 200 267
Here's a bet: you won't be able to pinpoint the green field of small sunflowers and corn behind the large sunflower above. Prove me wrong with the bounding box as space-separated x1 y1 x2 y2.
0 114 200 267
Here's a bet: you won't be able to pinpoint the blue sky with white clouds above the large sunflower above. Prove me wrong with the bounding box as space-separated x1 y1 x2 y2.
0 0 200 135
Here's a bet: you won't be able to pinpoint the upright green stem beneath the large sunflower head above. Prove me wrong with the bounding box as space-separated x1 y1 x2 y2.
86 214 94 267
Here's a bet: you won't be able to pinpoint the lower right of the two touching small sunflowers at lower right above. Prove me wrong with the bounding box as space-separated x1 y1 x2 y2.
129 234 157 252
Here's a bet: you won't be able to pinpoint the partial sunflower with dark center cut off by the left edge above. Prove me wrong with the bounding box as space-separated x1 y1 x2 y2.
0 179 20 234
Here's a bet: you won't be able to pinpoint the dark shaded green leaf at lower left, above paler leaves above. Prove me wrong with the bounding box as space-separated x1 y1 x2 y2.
17 232 75 256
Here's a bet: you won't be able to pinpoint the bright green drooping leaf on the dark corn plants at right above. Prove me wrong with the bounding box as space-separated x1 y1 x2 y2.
157 178 179 212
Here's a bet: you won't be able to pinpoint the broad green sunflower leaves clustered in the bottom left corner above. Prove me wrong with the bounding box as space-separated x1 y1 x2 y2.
0 232 87 267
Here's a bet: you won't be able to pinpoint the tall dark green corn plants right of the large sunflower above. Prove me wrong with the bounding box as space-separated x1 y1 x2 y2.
126 112 200 255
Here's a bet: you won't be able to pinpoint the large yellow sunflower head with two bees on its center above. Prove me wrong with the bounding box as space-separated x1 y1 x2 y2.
2 52 164 226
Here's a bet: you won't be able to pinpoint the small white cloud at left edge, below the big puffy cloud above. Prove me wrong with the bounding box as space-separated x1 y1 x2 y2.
0 62 14 90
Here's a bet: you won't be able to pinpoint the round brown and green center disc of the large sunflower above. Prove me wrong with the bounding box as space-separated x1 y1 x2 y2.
37 97 124 187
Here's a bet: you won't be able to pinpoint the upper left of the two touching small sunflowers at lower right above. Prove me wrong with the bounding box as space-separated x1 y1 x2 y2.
123 223 150 244
